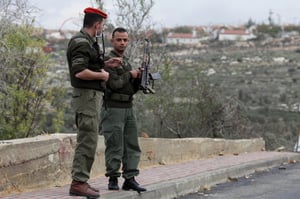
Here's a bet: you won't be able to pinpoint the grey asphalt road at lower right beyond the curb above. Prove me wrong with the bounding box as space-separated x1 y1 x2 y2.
180 163 300 199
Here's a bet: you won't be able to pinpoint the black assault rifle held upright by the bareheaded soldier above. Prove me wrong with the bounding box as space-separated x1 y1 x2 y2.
140 39 160 94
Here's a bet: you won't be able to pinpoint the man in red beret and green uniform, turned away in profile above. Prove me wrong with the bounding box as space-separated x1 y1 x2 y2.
67 8 122 198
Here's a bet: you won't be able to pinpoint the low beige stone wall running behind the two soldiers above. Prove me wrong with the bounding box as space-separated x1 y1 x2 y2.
0 134 265 195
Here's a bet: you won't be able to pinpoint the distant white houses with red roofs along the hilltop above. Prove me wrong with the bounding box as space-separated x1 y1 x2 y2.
43 23 300 52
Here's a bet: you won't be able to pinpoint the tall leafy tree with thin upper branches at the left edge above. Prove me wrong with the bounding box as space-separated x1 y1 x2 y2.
0 0 63 139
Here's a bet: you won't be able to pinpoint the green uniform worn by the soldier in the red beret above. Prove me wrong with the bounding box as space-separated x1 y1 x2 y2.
67 29 103 182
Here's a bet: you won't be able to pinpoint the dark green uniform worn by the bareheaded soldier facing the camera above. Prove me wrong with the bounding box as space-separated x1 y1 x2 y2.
101 51 141 179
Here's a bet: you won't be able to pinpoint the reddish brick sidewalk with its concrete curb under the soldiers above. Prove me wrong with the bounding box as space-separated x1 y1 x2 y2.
0 152 300 199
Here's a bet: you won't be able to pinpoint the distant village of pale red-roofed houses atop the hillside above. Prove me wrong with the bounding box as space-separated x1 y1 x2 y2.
40 25 300 50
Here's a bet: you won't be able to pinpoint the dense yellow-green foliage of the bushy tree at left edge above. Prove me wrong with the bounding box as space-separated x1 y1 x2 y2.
0 25 47 139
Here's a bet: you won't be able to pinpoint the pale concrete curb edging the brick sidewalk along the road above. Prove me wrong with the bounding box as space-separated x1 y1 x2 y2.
101 153 300 199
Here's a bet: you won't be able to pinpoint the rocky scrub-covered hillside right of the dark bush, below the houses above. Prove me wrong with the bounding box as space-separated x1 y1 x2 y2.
166 42 300 150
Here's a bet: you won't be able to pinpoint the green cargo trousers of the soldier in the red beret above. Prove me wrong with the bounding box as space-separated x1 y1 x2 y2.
71 88 102 182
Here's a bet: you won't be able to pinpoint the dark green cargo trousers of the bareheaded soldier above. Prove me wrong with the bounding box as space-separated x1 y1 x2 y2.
101 107 141 179
